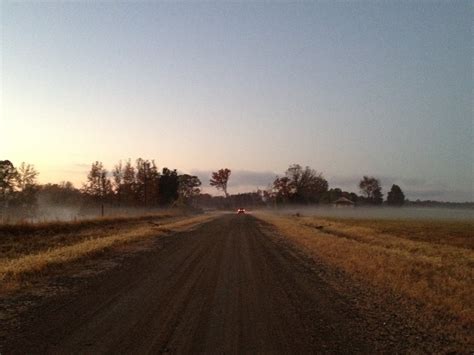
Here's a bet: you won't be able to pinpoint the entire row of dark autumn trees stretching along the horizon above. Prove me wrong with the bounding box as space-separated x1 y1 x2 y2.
0 158 412 220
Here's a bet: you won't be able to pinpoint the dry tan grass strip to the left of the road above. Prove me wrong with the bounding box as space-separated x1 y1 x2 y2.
0 214 215 285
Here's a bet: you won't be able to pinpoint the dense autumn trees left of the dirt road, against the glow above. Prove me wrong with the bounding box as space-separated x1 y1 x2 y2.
0 158 201 218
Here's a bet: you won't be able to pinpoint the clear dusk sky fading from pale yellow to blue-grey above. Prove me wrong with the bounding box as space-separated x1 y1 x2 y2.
0 0 474 201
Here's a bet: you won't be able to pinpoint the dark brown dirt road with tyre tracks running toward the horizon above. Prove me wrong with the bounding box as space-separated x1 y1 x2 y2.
4 214 382 354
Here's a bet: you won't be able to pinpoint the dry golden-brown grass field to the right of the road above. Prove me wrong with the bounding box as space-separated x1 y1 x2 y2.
258 213 474 329
